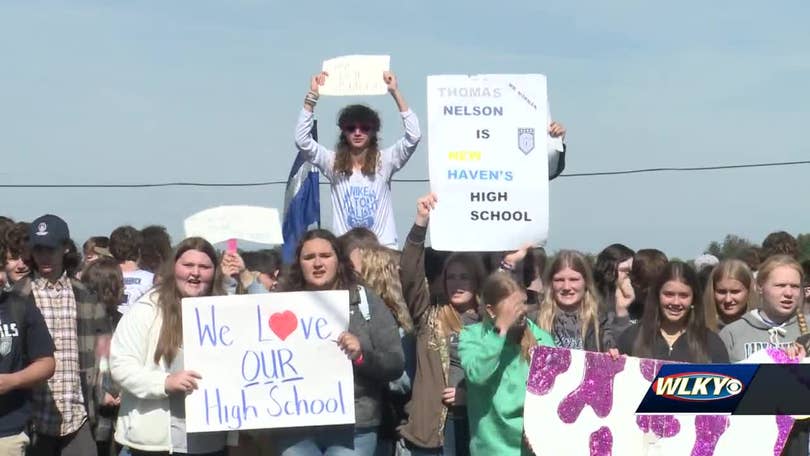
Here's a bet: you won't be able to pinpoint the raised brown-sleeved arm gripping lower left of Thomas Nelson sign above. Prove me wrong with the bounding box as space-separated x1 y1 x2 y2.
399 193 436 326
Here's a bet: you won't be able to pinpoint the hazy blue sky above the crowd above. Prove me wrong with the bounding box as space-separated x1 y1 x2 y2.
0 0 810 258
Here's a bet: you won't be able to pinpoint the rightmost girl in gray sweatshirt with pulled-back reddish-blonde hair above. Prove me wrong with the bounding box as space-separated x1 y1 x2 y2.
720 255 808 362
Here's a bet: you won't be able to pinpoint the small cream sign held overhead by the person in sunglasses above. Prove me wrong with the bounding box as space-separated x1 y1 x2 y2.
320 55 391 96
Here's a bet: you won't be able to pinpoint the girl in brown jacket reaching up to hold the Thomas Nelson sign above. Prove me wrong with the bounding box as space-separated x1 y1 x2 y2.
399 194 485 456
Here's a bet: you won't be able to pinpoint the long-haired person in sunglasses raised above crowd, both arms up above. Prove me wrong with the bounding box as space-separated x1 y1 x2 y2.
295 71 422 248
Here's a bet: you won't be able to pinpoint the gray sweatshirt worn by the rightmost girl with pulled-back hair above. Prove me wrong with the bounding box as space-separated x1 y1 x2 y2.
719 310 801 363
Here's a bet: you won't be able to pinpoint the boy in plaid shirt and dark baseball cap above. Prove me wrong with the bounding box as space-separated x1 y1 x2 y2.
21 214 111 456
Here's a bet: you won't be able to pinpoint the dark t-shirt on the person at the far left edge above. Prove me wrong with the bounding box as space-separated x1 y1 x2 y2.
0 292 54 437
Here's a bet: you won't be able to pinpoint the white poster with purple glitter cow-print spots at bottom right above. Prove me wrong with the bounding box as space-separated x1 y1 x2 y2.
524 347 793 456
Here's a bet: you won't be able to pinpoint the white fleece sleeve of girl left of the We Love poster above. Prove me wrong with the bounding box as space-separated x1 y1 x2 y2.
110 305 169 399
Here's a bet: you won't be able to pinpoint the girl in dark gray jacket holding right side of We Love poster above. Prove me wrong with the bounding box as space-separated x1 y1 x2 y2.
275 229 405 456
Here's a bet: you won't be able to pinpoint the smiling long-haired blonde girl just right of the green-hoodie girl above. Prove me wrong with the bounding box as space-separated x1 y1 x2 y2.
537 250 616 351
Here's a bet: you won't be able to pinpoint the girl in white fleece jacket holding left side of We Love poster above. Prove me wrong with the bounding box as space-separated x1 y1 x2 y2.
110 238 235 456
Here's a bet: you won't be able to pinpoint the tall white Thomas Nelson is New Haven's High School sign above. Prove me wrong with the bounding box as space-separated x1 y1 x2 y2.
427 74 549 251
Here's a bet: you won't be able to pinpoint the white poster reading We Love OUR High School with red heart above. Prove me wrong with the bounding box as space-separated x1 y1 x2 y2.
182 291 354 432
